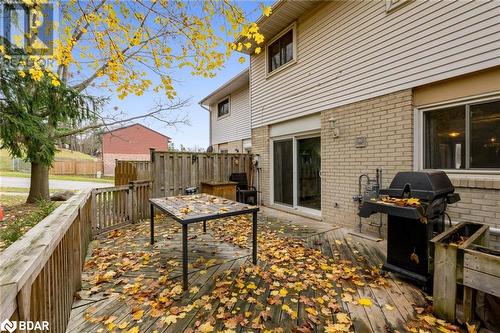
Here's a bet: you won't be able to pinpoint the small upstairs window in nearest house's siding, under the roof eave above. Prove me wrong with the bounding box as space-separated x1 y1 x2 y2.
267 25 295 73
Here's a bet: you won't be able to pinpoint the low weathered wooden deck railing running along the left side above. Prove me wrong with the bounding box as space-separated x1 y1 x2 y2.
0 181 151 332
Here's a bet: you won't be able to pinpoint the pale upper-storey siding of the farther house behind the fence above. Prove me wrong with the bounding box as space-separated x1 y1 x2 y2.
210 87 251 145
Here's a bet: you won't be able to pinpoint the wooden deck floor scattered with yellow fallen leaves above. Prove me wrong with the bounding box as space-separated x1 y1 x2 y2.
67 214 435 332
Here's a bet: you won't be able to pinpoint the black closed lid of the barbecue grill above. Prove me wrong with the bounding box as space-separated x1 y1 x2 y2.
380 171 455 201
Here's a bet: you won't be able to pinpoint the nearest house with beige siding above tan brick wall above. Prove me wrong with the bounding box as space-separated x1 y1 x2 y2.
202 0 500 239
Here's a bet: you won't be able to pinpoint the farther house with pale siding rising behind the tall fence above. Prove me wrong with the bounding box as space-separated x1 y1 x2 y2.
199 69 252 153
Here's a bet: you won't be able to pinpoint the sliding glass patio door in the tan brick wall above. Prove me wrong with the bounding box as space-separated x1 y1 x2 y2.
272 135 321 212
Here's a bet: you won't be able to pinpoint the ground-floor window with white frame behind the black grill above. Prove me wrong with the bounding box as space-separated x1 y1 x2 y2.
423 100 500 170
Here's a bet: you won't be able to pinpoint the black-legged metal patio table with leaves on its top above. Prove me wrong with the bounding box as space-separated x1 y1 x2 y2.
149 193 259 290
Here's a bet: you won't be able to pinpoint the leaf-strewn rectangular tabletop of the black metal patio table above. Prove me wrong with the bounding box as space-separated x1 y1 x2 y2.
149 193 259 224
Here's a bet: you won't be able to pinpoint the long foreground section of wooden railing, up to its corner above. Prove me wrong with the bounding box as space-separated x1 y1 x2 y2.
0 190 91 332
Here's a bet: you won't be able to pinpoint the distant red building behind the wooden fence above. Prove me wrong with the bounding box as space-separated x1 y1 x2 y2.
102 124 170 176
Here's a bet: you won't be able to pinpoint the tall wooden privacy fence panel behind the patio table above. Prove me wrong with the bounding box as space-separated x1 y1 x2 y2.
151 150 253 198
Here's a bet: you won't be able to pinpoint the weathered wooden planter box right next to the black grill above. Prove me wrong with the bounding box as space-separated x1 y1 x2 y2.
431 222 489 322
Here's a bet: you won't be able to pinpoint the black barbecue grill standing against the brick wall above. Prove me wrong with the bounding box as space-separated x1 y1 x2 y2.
358 171 460 287
